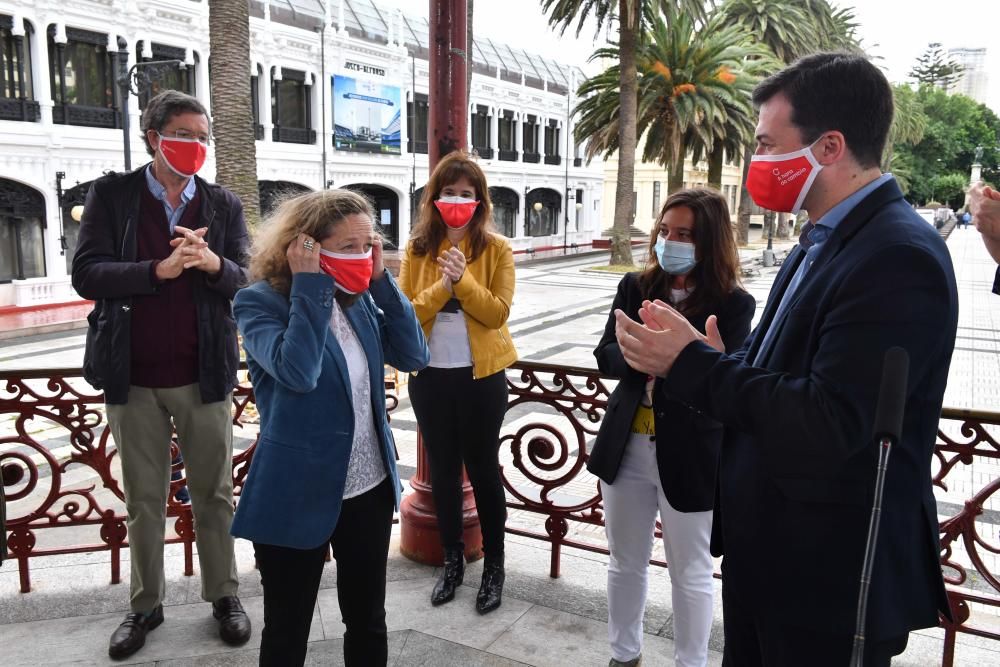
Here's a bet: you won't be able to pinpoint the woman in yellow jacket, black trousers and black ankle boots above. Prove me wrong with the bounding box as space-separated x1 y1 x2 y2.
399 152 517 614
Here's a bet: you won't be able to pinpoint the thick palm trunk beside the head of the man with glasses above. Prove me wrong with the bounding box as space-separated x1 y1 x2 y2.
208 0 260 227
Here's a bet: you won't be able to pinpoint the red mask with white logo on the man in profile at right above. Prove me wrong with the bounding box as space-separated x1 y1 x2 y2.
747 139 823 213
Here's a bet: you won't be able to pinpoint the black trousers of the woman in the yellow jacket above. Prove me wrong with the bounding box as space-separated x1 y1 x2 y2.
410 367 507 562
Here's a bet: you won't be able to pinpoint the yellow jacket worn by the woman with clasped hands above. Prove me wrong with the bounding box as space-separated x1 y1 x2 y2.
399 234 517 378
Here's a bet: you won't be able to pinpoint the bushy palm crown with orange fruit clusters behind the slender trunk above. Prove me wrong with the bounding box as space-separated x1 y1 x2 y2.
576 11 773 198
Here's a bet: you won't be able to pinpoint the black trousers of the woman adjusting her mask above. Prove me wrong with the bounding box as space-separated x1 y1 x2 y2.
253 477 395 667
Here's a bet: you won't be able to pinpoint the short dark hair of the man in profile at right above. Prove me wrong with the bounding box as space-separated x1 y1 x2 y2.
753 52 893 167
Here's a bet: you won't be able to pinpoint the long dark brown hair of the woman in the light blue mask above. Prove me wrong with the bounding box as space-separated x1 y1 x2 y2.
639 188 740 316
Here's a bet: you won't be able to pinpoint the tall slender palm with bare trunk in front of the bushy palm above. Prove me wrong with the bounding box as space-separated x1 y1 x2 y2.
541 0 705 264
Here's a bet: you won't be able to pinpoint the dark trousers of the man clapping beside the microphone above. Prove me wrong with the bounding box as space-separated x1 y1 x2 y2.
722 577 909 667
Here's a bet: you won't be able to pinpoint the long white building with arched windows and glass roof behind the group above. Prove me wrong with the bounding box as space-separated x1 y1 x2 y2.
0 0 610 308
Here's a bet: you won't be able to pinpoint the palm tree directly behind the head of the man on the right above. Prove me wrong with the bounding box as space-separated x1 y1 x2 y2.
718 0 860 244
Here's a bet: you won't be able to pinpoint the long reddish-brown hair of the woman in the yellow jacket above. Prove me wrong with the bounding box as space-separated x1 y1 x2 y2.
410 151 493 262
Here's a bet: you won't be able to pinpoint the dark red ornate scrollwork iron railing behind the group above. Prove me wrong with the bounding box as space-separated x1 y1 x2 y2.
0 362 1000 666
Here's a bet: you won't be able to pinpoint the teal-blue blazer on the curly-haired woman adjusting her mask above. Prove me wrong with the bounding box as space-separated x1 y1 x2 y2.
232 272 430 549
